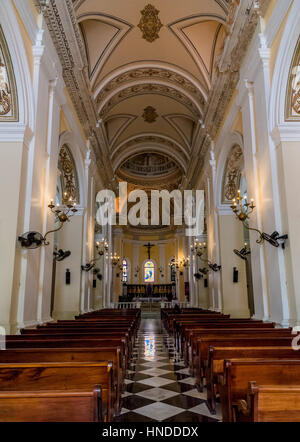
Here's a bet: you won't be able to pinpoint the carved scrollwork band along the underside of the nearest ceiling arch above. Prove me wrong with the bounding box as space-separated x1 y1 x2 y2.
98 80 203 118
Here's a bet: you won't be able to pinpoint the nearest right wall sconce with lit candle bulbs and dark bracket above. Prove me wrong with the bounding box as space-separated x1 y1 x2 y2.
231 190 288 249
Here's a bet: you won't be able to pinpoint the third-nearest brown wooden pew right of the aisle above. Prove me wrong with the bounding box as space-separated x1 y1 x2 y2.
205 344 300 414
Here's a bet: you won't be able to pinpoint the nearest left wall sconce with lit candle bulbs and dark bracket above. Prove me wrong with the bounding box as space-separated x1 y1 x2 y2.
18 192 77 249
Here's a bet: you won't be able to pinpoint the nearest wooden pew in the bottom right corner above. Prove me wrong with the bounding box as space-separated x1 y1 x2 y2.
236 382 300 422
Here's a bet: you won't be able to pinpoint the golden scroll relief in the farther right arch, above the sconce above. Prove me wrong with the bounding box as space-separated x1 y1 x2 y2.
222 145 244 203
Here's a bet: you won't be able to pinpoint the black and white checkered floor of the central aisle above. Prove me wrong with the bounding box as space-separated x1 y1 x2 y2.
116 319 221 422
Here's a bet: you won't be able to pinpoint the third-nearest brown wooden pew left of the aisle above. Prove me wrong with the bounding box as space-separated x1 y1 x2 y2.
0 347 125 415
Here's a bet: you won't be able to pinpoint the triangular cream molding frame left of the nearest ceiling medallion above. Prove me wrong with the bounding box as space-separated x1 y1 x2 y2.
77 12 133 87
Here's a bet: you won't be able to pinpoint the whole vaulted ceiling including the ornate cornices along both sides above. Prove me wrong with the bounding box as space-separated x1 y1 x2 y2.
35 0 269 187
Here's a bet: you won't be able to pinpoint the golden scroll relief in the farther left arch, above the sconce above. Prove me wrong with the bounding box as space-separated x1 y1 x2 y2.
58 144 80 204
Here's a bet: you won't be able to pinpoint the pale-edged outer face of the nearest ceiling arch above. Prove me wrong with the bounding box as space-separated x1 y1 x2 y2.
94 62 207 108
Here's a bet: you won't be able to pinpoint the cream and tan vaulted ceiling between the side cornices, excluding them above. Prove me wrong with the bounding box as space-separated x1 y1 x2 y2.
74 0 228 188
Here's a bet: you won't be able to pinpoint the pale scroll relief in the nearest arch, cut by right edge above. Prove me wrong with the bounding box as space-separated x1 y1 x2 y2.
286 39 300 120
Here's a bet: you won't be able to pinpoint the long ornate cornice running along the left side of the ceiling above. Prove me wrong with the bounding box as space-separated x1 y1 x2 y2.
34 0 113 185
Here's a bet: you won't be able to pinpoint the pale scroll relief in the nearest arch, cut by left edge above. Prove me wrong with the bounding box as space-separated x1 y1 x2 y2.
0 26 18 121
